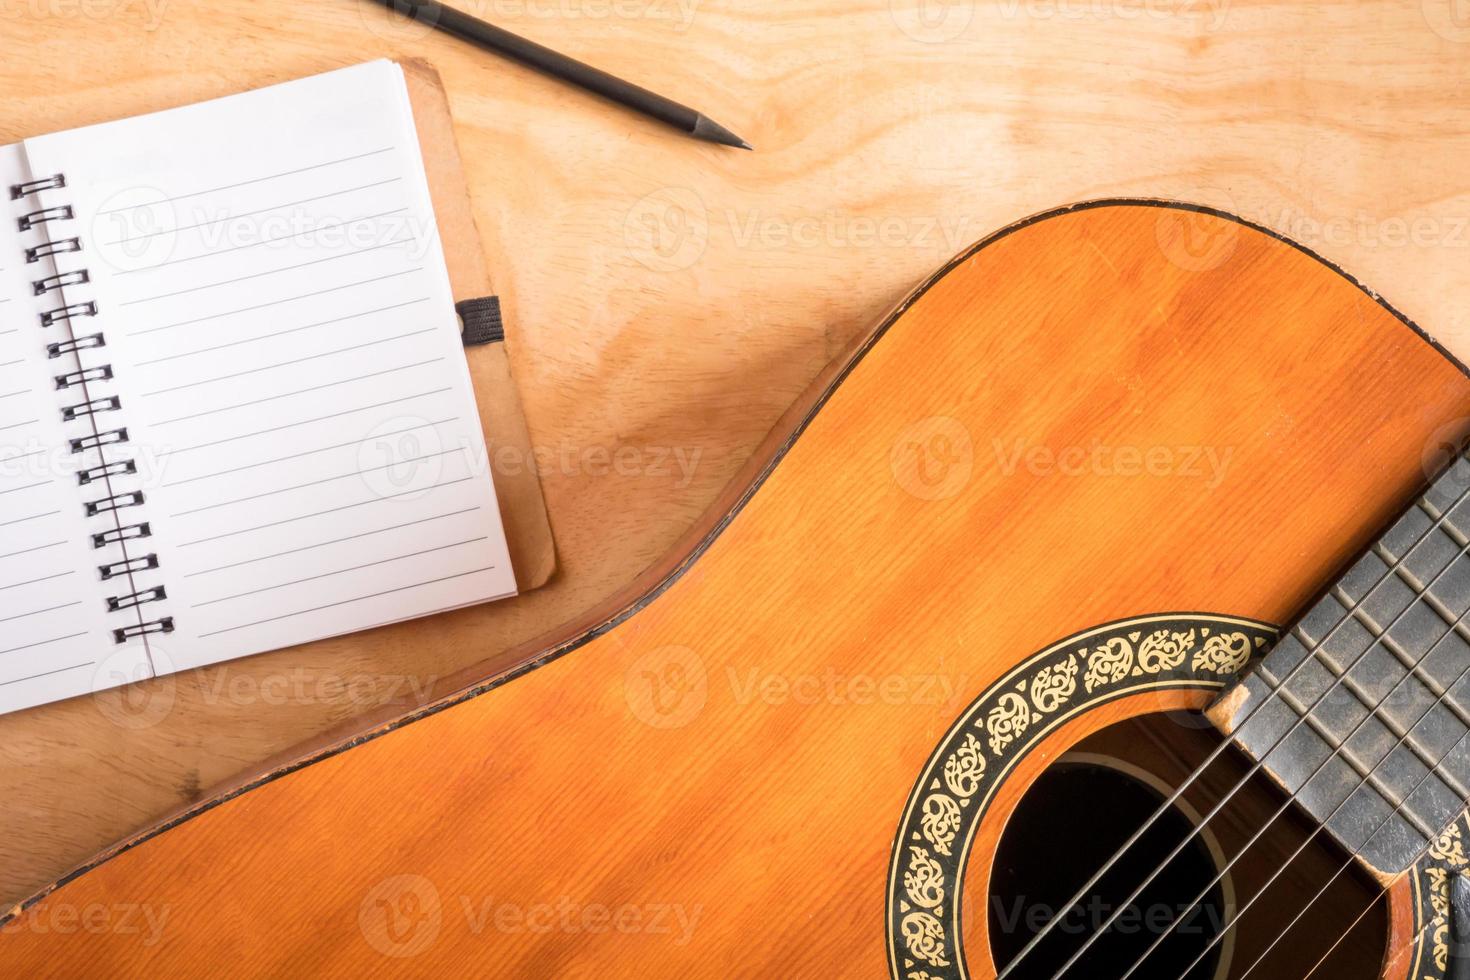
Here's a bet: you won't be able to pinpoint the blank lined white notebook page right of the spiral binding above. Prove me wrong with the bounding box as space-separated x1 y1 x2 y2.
26 62 515 670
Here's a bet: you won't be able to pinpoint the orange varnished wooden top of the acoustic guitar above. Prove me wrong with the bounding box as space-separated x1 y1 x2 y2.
0 206 1470 977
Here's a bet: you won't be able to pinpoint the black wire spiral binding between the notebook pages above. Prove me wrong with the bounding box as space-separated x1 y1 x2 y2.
10 173 173 644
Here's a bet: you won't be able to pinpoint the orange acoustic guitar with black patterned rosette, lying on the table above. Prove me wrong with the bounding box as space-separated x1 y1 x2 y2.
0 201 1470 980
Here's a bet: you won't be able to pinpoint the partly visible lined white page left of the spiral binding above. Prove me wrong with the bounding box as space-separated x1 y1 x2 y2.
0 145 153 713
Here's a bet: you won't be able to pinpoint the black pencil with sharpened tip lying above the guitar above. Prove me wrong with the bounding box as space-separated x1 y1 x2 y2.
367 0 754 150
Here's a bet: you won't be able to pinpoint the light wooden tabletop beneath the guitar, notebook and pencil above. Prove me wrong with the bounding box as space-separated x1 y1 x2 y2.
0 0 1470 901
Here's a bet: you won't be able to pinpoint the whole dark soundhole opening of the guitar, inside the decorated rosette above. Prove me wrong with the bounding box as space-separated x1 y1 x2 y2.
964 714 1388 980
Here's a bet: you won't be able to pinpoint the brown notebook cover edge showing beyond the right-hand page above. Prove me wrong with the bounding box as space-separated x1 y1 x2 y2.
398 59 556 592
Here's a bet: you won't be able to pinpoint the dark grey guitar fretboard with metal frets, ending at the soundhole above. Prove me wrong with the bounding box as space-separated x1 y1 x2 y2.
1210 457 1470 879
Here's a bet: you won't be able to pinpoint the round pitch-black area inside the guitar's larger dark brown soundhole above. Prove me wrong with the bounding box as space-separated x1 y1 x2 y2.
988 763 1226 980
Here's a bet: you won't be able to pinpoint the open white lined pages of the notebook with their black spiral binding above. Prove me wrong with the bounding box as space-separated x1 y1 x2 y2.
0 62 516 711
